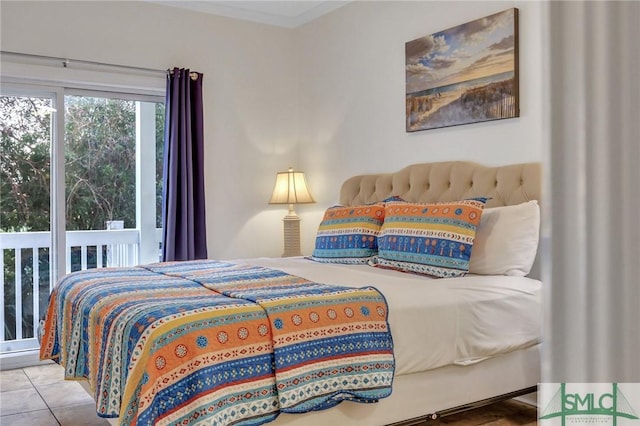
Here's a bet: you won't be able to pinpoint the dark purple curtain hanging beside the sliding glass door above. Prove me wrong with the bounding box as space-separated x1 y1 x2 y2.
162 68 207 261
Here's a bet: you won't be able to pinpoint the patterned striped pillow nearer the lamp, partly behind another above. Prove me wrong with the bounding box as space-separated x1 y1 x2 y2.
311 203 384 263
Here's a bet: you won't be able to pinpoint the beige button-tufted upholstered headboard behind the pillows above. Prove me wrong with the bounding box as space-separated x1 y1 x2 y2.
340 161 541 207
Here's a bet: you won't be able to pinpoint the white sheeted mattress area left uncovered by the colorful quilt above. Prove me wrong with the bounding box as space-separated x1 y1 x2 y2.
234 257 542 375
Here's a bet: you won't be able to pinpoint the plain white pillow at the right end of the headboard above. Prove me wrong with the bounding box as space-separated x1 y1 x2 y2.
469 200 540 277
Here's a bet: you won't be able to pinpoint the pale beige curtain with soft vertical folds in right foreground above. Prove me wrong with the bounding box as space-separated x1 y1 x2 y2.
543 1 640 383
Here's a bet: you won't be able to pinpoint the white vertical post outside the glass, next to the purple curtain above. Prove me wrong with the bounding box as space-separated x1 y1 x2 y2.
136 102 158 264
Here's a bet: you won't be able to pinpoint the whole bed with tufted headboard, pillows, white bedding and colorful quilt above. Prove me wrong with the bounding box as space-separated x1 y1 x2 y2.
41 161 542 426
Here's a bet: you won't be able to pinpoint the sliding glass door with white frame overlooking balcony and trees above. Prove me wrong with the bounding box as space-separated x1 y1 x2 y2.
0 86 164 354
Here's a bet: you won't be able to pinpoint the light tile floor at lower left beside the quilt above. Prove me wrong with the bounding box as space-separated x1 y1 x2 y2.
0 363 109 426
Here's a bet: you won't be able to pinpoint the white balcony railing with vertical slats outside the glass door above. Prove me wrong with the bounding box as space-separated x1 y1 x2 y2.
0 229 161 353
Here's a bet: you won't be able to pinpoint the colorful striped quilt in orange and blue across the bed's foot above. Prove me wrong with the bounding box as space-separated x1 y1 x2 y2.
40 260 394 425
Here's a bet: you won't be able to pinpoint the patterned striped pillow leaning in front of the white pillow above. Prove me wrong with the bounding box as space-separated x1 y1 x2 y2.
372 198 487 278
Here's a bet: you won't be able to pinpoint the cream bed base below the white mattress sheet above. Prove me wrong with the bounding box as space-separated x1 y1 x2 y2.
92 345 540 426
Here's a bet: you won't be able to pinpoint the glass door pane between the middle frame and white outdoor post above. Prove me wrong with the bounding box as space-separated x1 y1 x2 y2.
65 95 136 272
